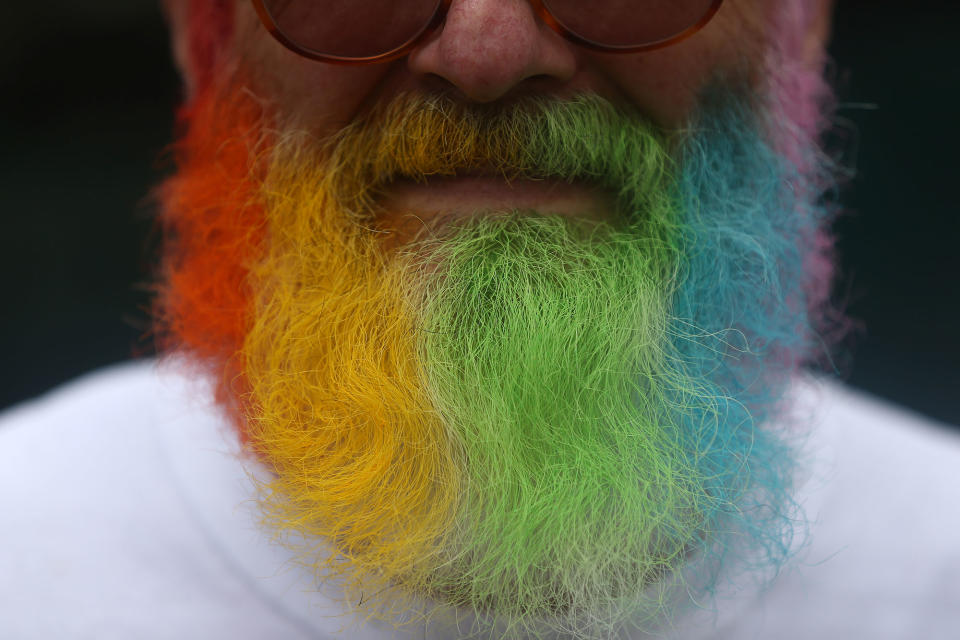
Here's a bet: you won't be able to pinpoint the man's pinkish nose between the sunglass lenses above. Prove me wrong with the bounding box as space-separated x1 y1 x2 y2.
408 0 577 102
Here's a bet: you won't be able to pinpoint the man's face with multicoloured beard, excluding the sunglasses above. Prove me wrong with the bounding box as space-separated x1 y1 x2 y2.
161 0 826 635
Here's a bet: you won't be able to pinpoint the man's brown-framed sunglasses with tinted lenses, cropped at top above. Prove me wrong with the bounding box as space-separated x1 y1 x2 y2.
253 0 723 64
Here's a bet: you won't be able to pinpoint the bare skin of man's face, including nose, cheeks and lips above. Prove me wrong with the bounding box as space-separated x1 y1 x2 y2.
237 0 778 235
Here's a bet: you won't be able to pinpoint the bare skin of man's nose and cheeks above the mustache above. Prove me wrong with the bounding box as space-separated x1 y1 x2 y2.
238 0 764 126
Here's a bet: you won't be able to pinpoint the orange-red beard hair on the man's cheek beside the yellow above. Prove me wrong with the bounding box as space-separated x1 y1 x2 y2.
154 83 270 424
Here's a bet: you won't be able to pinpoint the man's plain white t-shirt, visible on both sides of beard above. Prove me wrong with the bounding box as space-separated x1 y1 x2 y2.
0 361 960 640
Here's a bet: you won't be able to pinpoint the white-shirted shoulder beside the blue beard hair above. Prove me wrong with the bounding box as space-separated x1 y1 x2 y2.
740 380 960 640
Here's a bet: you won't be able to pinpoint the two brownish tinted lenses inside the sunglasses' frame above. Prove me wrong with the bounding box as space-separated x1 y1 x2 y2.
263 0 715 58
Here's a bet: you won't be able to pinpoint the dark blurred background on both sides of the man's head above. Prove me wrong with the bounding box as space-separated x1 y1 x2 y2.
0 0 960 425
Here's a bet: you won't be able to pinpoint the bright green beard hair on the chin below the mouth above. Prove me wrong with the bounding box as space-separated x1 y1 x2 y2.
398 211 704 632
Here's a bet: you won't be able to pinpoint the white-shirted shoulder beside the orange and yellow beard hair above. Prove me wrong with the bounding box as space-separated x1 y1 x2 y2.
0 361 320 639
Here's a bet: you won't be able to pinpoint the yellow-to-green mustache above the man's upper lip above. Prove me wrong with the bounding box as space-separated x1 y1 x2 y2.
268 93 673 212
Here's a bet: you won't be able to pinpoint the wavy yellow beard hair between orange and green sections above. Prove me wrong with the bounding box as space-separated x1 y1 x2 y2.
243 134 459 608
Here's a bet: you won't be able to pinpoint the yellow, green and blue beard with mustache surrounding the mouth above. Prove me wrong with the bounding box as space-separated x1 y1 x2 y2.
163 86 825 637
